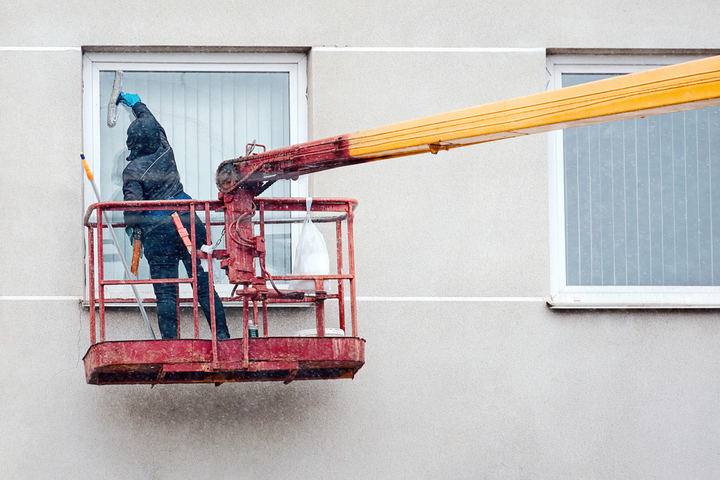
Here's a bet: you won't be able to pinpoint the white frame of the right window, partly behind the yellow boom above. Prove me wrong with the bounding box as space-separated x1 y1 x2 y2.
547 55 720 308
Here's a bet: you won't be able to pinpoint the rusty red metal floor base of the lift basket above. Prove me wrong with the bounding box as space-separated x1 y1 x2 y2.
83 337 365 385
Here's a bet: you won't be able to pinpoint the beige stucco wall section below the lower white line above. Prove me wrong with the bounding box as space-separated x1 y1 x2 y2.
0 302 720 479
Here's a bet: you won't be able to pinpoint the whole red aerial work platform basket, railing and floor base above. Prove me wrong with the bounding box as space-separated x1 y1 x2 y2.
83 198 365 385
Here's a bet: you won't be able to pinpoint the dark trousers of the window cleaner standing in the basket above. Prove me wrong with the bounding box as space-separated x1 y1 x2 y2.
143 213 230 339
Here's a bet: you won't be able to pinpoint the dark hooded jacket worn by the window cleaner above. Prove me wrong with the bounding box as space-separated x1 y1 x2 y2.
123 102 190 230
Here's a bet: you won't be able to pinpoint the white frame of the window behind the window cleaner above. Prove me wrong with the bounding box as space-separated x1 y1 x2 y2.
83 52 308 301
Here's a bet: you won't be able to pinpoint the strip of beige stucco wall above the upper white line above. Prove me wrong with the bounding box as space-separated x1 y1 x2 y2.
0 0 719 48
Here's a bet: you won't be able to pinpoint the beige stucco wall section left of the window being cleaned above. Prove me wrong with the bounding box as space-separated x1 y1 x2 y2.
0 51 84 296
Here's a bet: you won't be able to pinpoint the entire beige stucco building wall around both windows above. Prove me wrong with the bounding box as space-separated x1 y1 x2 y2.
0 0 720 479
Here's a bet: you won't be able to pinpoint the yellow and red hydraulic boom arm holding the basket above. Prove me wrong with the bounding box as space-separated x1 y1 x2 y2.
216 57 720 285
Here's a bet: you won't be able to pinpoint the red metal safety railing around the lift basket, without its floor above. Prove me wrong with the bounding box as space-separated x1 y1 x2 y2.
84 197 358 346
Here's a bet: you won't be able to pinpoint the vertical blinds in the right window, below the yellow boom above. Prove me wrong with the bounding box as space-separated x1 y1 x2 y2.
562 74 720 286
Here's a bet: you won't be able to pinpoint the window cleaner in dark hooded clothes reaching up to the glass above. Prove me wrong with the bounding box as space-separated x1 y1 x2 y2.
120 93 230 339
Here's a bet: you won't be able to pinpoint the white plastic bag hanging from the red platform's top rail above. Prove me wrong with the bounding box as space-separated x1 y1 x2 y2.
289 197 330 292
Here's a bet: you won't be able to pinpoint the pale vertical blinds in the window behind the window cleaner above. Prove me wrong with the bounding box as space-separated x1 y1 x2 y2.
99 71 291 282
